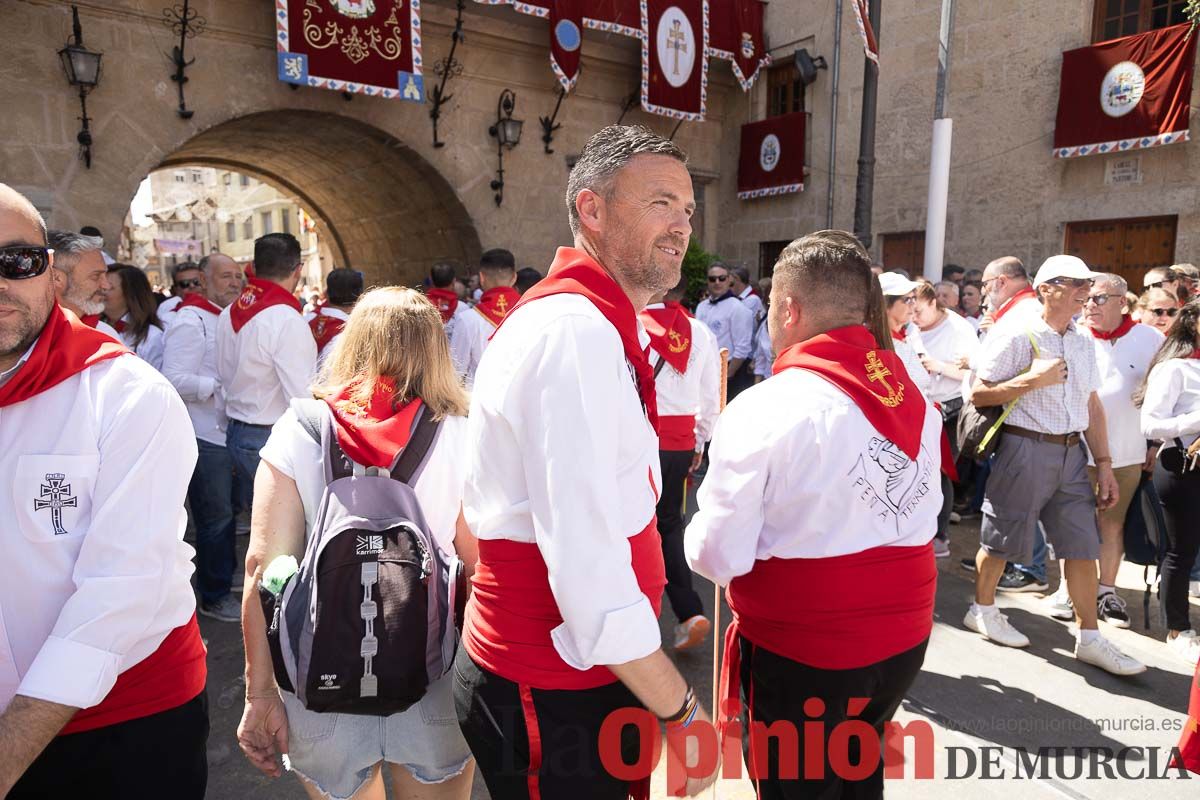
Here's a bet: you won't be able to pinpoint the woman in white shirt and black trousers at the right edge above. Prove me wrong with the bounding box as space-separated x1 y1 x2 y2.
1134 301 1200 664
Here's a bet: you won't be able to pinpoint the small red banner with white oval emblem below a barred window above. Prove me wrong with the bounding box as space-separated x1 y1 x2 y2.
738 112 805 200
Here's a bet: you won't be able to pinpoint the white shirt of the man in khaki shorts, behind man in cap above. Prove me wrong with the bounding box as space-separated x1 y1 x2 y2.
1080 325 1166 469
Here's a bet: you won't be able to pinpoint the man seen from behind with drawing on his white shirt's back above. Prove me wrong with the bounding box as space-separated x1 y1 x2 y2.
685 230 942 798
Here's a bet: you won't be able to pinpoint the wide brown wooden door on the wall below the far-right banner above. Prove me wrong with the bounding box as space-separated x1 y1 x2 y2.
1064 216 1178 294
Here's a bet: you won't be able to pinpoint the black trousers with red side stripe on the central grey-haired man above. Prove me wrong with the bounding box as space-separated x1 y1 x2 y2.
454 648 658 800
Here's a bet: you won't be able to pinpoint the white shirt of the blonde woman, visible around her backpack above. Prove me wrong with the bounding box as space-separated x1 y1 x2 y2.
259 408 467 555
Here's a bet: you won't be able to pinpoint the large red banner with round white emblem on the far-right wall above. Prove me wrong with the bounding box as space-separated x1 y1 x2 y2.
1054 24 1196 158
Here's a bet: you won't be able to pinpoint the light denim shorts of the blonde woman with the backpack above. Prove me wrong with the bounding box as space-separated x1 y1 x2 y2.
280 673 470 800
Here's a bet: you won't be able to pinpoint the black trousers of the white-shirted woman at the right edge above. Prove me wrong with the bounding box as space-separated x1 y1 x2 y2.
1154 462 1200 631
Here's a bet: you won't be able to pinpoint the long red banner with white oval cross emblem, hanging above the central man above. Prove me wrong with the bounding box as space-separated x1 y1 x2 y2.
641 0 708 121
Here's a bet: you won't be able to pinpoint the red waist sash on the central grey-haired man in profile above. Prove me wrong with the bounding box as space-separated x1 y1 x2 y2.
462 518 667 690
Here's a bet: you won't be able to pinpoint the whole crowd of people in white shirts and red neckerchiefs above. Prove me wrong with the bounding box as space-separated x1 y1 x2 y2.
0 126 1200 800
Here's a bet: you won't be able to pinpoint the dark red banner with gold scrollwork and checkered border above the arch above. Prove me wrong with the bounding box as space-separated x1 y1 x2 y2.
275 0 425 103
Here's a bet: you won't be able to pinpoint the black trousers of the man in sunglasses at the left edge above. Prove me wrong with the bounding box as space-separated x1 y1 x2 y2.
7 692 209 800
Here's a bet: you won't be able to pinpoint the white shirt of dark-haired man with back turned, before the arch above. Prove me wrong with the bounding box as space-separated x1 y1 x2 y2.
217 305 317 425
